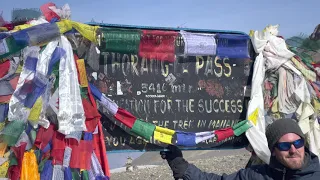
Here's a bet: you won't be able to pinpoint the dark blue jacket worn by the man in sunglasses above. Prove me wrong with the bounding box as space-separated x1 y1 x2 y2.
183 149 320 180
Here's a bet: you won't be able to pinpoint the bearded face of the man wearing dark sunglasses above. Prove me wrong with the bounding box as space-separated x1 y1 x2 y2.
273 133 304 170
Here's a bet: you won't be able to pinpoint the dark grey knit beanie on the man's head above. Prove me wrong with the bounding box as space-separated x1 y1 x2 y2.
266 119 305 152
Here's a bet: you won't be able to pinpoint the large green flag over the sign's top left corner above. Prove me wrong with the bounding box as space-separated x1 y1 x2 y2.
100 28 141 54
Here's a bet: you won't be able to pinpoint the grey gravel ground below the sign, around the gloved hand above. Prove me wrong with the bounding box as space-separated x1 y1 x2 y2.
111 154 250 180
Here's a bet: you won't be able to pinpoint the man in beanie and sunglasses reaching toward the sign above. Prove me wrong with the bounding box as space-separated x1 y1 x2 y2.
161 119 320 180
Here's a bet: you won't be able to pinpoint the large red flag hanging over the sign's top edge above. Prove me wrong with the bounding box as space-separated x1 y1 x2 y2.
139 30 178 62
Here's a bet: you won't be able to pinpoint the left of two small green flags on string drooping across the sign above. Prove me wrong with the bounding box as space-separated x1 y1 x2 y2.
131 119 156 140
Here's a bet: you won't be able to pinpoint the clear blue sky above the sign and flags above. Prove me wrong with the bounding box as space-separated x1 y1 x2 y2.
0 0 320 38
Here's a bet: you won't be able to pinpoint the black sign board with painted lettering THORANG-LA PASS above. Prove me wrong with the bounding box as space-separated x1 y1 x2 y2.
86 27 253 151
